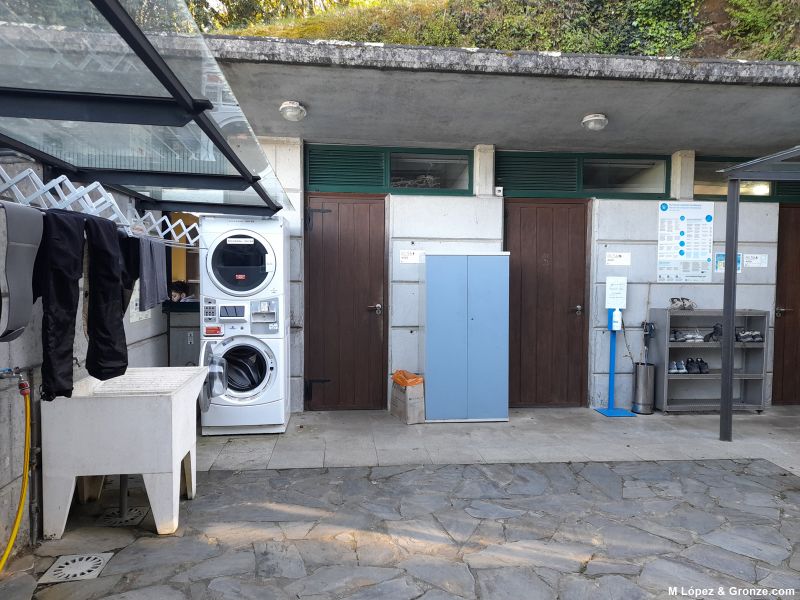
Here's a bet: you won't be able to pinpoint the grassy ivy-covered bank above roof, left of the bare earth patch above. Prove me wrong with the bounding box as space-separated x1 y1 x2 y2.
222 0 699 55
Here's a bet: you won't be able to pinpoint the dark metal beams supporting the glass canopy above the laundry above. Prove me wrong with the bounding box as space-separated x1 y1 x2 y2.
0 0 283 214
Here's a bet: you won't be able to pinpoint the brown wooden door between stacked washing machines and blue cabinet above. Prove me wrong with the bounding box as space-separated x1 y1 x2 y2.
304 195 389 410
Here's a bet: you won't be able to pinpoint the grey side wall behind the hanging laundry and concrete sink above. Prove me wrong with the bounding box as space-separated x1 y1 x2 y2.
0 158 167 549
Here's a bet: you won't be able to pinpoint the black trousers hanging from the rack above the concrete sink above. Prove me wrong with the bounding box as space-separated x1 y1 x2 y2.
34 209 128 400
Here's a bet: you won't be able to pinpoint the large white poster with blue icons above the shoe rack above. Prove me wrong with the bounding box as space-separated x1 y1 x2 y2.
657 202 714 283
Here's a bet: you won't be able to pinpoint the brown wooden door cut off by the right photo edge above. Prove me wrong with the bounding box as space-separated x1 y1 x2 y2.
772 204 800 404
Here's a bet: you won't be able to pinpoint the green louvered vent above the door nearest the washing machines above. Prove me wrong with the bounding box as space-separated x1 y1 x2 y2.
306 146 386 191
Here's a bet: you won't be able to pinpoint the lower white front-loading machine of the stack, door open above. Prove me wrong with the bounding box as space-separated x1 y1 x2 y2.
200 335 289 435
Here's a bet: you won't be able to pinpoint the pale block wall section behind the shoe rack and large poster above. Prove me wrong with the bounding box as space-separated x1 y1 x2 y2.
589 153 778 407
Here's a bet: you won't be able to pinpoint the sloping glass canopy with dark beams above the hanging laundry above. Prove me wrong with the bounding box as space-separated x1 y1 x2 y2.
0 0 290 212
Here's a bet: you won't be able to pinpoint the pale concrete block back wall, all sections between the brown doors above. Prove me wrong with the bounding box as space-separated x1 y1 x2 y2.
253 138 778 412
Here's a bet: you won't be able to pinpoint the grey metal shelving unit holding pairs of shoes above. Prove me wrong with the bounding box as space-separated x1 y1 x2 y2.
648 308 769 413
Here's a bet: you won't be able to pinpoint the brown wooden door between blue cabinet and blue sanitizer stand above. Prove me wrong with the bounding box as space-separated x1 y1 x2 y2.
505 199 588 407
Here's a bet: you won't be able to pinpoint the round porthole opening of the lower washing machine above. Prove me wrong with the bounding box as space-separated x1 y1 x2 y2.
208 335 277 406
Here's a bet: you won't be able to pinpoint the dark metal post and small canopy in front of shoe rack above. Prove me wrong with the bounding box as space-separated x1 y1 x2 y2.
719 145 800 442
